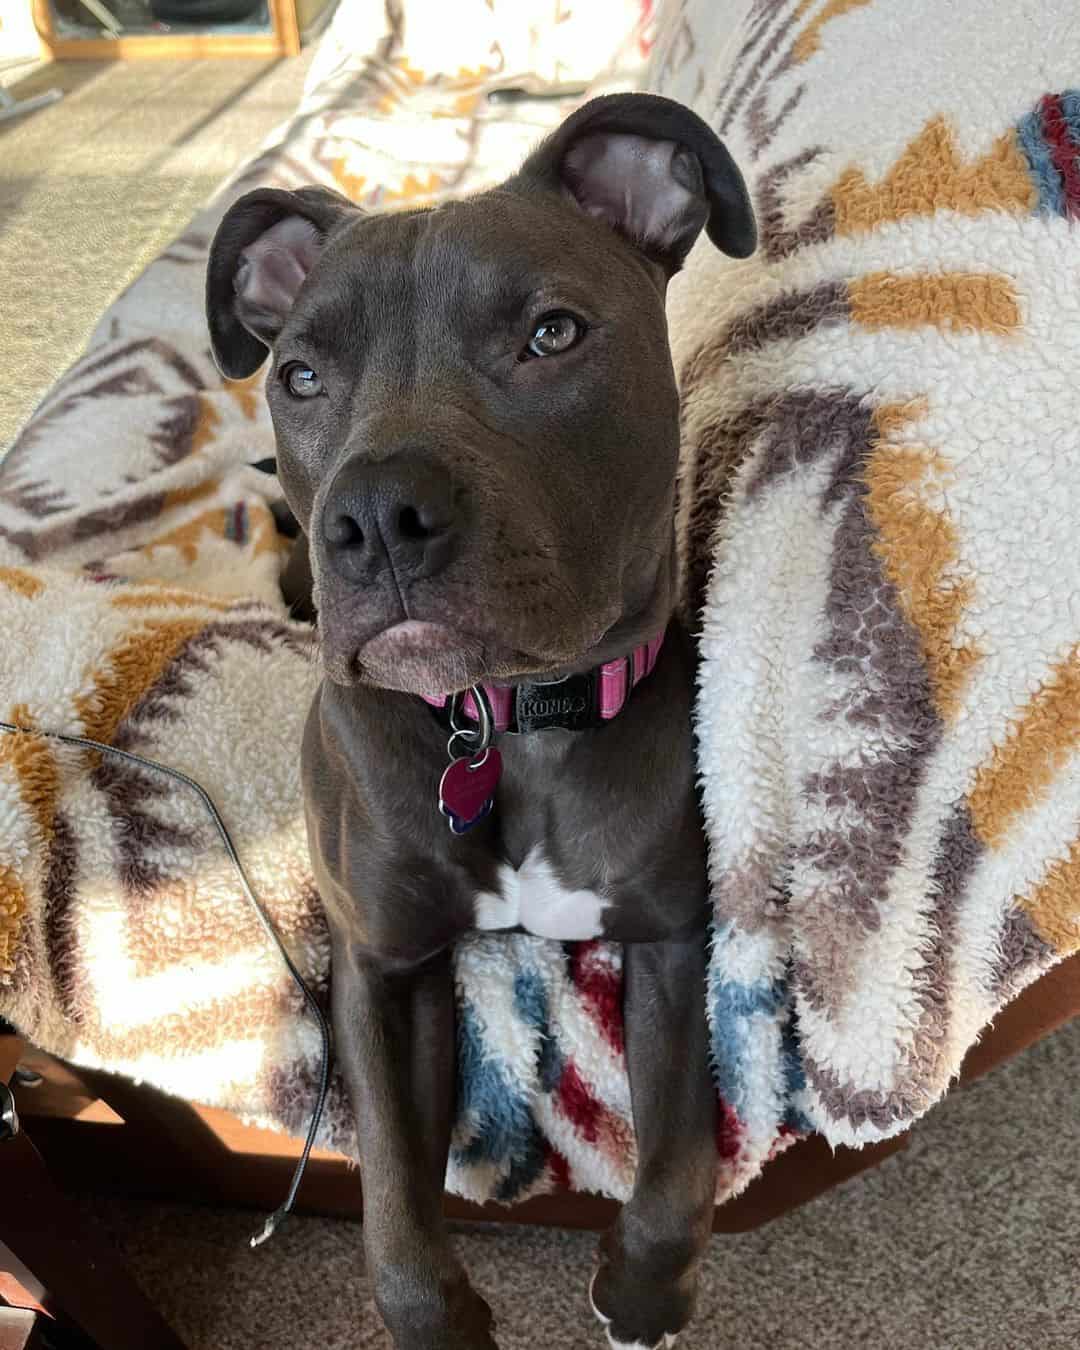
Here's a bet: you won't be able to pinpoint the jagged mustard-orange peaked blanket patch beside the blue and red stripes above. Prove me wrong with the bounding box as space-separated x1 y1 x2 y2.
832 117 1038 235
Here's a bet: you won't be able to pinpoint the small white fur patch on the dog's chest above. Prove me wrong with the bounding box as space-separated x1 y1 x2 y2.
474 848 608 942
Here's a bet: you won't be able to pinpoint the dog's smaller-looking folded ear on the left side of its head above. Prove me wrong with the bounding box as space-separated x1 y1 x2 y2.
207 188 360 379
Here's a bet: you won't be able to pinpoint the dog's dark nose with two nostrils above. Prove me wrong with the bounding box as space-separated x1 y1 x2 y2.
323 460 460 582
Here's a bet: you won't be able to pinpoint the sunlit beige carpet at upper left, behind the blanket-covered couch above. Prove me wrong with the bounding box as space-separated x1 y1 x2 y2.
0 53 311 452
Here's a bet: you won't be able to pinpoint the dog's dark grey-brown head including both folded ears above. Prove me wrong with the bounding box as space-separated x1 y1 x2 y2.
207 95 755 693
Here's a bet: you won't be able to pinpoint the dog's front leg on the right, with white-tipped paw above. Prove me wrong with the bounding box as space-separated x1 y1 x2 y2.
593 933 717 1347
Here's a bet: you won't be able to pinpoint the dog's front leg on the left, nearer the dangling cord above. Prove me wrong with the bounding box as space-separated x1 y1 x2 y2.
332 944 495 1350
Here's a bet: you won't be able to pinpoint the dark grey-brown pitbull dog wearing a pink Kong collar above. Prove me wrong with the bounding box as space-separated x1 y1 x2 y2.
207 95 755 1350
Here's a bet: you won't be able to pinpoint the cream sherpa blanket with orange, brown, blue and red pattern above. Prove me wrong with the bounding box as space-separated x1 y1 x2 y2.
0 0 1080 1200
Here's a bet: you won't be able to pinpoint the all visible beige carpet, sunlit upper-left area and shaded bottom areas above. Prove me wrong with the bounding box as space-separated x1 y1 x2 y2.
0 47 1080 1350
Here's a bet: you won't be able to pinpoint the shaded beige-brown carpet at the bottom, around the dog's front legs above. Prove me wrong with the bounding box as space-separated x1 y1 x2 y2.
77 1021 1080 1350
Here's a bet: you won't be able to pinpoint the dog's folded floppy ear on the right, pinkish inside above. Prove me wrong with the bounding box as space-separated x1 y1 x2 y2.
512 93 757 273
